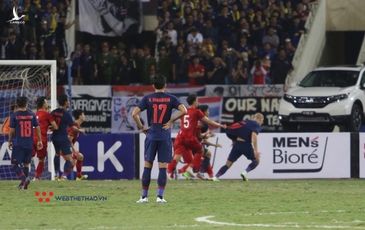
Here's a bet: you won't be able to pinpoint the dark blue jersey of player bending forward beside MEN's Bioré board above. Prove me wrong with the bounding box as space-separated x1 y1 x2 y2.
226 120 262 143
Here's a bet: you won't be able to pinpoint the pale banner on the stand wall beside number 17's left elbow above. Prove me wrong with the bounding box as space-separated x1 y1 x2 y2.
111 96 147 133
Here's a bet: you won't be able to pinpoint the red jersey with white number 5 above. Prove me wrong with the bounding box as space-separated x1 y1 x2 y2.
180 107 205 137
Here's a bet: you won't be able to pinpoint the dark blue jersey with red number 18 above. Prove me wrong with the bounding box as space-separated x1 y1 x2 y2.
10 110 39 149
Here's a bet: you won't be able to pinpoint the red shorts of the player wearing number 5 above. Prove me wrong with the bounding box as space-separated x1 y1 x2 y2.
174 136 203 155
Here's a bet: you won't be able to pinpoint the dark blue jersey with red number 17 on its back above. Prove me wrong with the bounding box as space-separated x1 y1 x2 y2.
138 92 181 140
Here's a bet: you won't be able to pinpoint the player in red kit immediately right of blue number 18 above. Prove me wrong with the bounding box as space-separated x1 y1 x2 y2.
32 97 58 180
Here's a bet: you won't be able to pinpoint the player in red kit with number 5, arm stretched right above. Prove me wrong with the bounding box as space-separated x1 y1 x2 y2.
167 95 226 178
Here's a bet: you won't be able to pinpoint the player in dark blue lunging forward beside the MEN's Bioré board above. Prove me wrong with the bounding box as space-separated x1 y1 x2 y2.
213 113 264 181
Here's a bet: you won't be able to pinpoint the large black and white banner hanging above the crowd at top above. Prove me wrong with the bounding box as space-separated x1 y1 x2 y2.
78 0 143 37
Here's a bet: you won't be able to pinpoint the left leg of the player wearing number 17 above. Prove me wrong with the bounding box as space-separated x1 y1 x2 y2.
137 137 157 203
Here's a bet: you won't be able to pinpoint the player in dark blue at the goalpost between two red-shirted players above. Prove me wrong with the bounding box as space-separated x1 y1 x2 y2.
51 95 74 180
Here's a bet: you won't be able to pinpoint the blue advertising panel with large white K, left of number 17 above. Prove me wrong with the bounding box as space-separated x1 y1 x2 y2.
78 134 135 179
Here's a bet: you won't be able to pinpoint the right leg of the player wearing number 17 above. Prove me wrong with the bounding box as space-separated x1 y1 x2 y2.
156 140 172 203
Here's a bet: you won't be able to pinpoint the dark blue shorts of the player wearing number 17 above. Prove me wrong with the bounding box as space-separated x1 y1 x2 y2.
144 137 172 163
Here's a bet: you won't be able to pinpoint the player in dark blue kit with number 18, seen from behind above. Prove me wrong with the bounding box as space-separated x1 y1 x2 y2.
8 97 43 189
